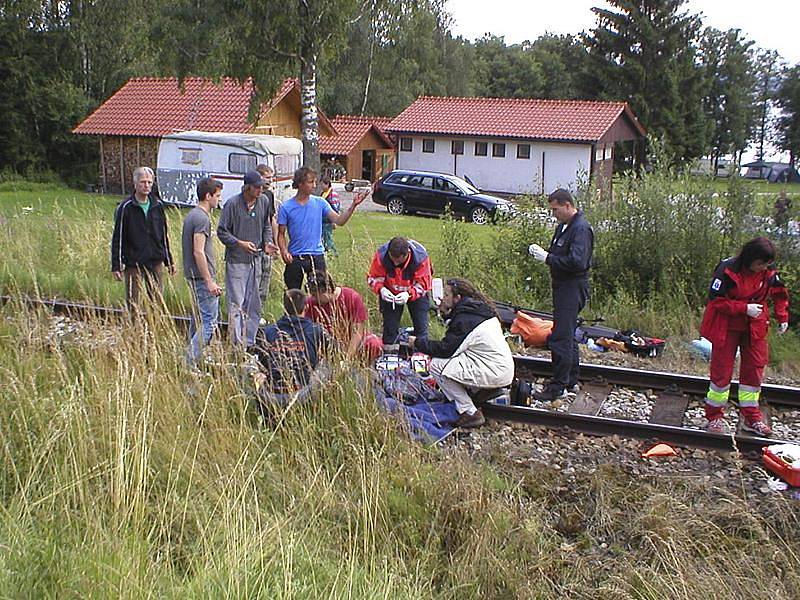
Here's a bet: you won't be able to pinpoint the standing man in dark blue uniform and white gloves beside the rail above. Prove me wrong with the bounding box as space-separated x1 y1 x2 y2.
528 189 594 402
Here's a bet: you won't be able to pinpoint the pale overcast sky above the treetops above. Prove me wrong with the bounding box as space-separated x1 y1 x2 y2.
447 0 800 64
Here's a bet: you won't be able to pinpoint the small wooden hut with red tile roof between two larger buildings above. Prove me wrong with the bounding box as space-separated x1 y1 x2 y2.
319 115 395 181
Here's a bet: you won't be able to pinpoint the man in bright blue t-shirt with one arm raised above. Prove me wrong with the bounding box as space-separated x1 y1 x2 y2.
278 167 368 290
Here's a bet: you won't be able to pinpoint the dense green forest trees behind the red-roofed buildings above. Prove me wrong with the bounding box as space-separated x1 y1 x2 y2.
0 0 800 185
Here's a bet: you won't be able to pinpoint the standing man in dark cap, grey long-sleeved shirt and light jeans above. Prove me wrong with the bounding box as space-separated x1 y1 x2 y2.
217 171 277 348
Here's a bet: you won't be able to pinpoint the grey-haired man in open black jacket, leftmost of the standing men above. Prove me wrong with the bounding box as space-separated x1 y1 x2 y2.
111 167 175 312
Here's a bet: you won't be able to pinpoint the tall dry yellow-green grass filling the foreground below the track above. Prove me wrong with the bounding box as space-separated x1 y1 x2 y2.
0 305 800 599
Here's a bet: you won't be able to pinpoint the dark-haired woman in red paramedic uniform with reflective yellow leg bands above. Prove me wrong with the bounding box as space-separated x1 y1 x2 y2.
700 237 789 436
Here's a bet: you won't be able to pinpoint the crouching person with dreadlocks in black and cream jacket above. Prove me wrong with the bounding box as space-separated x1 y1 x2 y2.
408 279 514 427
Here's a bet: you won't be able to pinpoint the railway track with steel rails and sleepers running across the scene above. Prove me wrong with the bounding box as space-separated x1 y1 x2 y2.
6 296 800 456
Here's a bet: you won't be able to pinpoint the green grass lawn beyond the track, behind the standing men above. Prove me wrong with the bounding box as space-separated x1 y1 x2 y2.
0 189 491 328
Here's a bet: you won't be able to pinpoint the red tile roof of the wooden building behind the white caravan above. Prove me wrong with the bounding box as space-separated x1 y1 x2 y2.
72 77 330 137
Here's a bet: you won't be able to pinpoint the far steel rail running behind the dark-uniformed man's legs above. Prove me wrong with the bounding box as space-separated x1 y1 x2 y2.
514 355 800 408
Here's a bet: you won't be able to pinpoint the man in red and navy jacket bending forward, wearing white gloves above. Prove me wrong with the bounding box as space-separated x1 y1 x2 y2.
367 237 433 344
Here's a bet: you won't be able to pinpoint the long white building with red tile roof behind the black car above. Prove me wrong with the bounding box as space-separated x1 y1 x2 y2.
386 96 645 194
